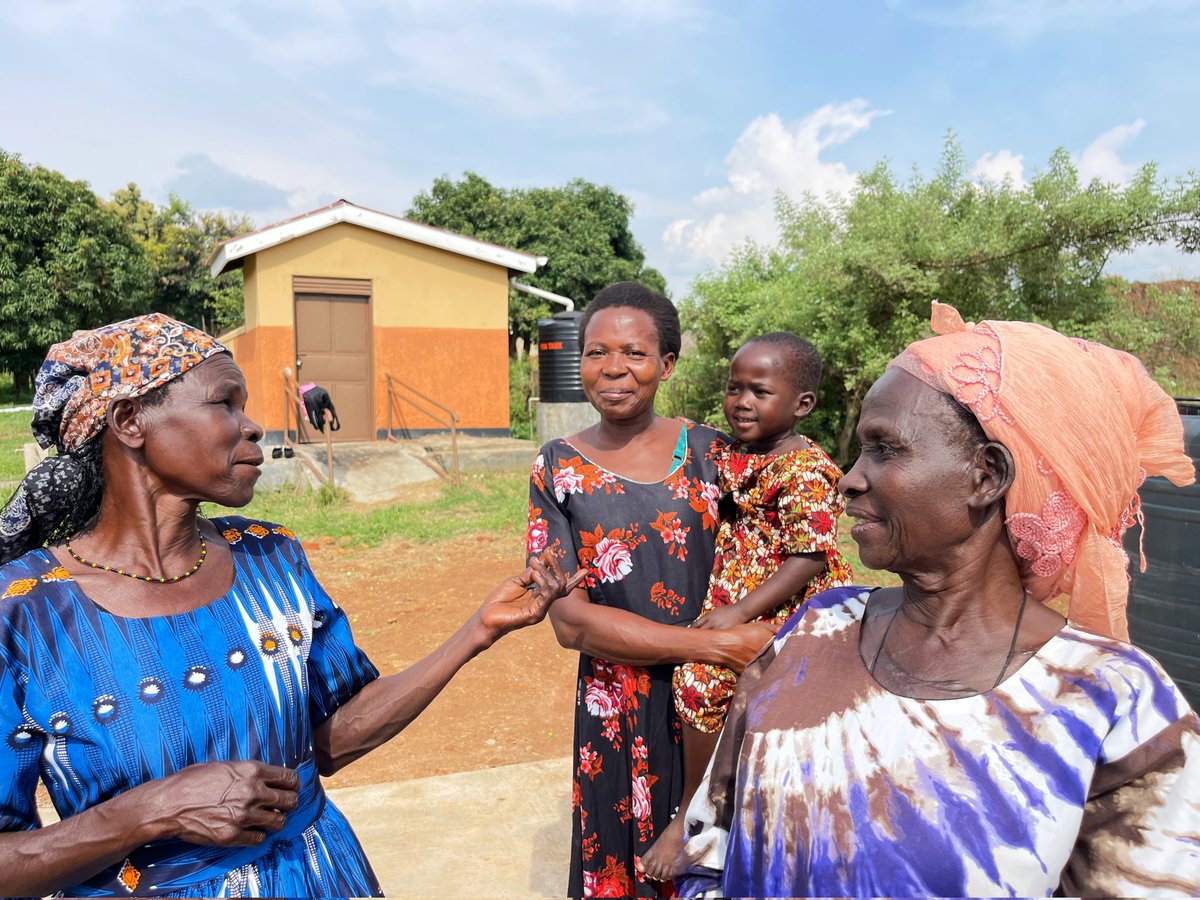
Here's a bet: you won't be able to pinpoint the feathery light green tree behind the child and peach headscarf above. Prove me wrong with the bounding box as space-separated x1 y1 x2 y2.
666 134 1200 472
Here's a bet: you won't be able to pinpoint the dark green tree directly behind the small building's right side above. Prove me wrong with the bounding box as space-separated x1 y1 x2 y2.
406 172 666 356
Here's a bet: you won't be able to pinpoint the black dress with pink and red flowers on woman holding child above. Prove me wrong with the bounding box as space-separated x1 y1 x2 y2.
528 420 727 896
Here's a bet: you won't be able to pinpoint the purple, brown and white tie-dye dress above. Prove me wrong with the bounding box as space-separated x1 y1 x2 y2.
679 588 1200 896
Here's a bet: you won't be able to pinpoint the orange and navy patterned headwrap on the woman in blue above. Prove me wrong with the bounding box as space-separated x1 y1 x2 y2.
31 312 227 454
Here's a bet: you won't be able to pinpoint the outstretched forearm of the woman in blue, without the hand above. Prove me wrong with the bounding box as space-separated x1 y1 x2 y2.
314 614 497 775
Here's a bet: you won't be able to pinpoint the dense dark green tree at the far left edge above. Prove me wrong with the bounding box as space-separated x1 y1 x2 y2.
0 150 150 391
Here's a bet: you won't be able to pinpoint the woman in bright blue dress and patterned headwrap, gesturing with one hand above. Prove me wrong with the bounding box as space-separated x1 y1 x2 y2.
0 314 574 896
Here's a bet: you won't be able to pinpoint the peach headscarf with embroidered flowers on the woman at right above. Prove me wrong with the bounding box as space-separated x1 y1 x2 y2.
888 302 1195 641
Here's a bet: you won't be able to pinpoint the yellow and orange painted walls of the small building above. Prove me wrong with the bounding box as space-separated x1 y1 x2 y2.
230 222 509 441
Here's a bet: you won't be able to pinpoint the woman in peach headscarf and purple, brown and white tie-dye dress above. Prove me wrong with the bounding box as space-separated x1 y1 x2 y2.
677 305 1200 896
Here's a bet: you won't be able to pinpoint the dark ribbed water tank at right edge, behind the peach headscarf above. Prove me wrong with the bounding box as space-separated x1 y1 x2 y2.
1124 400 1200 709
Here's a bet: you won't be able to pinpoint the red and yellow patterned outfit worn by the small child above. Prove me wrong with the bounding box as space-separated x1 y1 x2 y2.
672 440 854 734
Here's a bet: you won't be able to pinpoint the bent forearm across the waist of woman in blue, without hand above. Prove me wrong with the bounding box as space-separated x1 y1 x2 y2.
0 785 168 896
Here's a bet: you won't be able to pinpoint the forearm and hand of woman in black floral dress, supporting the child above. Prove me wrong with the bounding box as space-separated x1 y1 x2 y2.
550 588 775 672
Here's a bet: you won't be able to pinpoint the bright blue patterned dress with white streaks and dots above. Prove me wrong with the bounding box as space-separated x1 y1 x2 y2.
0 517 380 896
